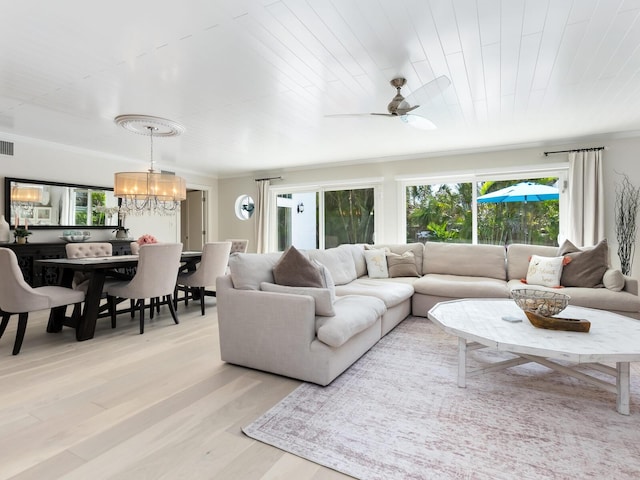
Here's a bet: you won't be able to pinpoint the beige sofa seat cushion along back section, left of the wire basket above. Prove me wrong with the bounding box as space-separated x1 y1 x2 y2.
413 273 510 298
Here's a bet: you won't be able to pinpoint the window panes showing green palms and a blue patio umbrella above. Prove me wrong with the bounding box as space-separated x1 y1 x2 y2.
404 169 566 245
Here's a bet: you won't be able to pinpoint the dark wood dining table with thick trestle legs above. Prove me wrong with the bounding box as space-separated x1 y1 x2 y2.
36 252 202 341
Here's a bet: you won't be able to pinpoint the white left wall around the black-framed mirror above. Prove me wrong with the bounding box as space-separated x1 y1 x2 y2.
0 135 218 246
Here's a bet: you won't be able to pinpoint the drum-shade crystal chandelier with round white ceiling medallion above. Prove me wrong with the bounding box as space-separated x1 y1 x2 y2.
113 115 187 215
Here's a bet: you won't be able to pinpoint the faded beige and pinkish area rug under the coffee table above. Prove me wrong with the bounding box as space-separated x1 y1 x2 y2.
243 317 640 480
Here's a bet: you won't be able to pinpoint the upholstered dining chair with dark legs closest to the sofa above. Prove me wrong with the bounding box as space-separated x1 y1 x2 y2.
174 241 231 315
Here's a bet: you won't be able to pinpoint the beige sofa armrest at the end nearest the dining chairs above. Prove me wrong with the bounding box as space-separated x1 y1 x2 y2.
216 275 316 371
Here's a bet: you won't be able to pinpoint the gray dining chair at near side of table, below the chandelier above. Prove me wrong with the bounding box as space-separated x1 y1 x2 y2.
106 243 182 334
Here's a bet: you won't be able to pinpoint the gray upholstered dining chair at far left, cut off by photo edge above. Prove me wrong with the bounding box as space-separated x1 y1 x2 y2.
0 248 85 355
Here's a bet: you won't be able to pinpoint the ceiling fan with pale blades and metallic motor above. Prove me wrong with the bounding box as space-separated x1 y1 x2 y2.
326 75 451 130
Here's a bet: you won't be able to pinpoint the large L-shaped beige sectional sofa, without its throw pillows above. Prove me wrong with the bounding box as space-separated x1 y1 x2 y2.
217 243 640 385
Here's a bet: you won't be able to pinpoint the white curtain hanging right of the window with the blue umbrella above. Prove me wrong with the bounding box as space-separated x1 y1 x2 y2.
567 150 605 246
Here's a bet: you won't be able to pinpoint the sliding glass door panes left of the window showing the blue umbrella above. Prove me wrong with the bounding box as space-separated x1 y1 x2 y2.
273 186 376 251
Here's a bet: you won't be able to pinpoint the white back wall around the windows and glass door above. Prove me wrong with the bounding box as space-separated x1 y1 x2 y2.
219 136 640 273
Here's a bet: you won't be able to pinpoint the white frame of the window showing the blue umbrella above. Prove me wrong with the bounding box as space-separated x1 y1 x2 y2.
396 162 569 248
